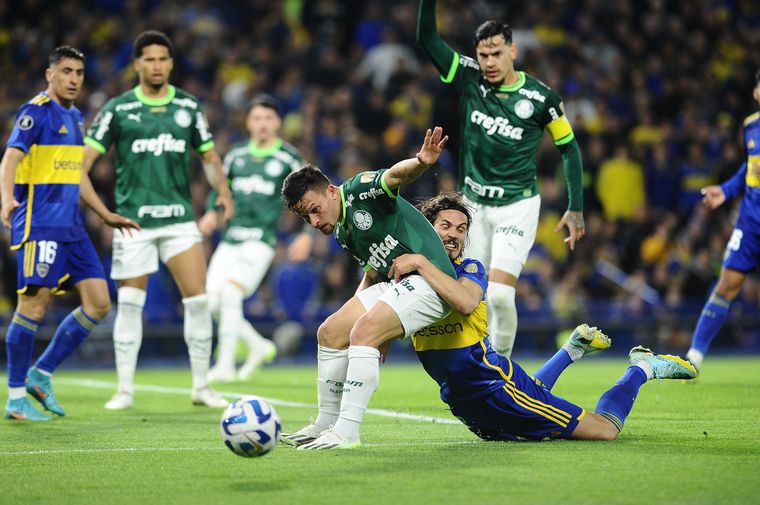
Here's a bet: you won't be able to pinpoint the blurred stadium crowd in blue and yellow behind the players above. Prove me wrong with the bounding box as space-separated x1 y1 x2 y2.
0 0 760 352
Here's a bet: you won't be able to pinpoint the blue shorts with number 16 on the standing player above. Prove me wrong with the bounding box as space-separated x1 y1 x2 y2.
16 238 106 294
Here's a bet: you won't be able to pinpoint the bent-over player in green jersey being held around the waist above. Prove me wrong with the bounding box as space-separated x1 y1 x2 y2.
282 127 454 449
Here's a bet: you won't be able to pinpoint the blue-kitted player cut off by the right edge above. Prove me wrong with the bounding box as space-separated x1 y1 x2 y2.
686 70 760 368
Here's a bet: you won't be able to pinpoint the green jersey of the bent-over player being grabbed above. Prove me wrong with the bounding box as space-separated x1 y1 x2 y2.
333 170 456 278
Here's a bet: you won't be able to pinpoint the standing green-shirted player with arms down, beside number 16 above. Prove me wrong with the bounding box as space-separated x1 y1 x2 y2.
84 31 233 410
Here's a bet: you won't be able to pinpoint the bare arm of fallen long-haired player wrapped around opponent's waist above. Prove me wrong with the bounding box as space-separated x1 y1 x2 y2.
388 254 483 316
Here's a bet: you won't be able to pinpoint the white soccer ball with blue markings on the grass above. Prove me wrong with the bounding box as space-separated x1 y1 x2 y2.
219 395 282 458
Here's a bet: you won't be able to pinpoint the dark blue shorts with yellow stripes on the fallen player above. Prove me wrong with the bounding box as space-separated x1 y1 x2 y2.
451 356 586 440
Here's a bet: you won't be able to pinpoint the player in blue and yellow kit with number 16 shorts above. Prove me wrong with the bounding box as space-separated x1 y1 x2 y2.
0 46 139 421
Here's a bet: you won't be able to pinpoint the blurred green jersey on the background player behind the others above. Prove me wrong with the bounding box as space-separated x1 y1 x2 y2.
217 139 303 247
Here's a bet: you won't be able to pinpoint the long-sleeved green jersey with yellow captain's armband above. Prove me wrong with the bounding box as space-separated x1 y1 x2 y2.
417 0 583 211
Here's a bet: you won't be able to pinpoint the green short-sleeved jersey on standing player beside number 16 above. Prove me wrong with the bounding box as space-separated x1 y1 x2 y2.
84 86 214 228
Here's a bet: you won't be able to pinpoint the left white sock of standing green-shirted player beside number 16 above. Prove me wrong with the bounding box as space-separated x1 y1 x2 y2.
113 286 145 394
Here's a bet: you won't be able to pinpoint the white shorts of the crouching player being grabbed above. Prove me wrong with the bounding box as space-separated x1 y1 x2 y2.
357 275 451 338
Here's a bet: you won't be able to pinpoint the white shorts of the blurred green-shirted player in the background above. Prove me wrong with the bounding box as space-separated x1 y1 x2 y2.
206 240 274 298
